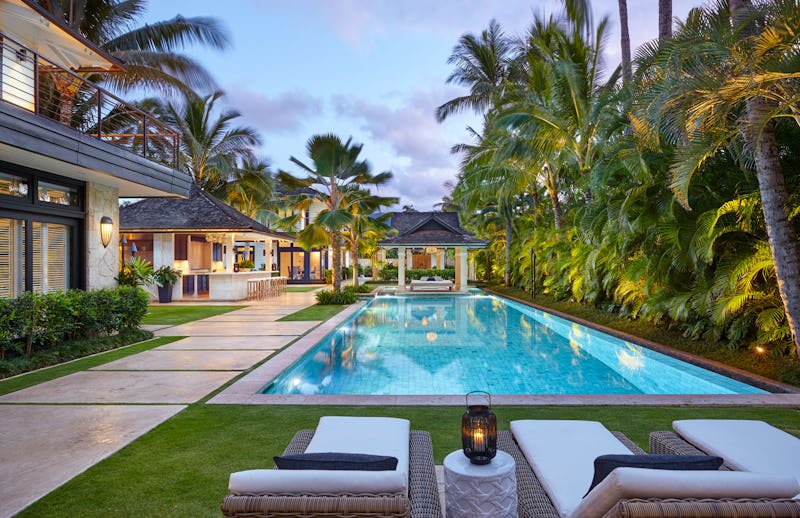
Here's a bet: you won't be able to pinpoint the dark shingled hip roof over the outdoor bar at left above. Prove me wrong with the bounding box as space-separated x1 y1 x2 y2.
119 184 295 241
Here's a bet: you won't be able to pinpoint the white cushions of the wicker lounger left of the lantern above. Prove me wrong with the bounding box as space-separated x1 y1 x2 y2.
228 416 411 495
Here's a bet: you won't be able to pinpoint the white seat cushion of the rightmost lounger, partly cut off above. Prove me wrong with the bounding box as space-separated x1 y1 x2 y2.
672 419 800 482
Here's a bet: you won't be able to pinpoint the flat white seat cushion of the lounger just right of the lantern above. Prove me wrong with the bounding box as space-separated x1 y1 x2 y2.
511 420 631 516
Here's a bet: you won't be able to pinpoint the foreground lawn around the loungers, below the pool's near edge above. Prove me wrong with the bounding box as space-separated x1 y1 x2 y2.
18 404 800 518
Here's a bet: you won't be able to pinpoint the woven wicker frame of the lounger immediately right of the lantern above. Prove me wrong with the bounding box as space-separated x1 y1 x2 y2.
497 431 800 518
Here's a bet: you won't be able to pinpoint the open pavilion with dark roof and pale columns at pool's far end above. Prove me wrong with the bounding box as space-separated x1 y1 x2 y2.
379 212 488 292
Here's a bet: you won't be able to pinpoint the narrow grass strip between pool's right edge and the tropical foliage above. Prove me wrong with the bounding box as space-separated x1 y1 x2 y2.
488 285 800 386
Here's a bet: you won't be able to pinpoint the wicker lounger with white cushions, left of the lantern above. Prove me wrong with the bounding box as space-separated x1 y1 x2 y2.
222 416 441 518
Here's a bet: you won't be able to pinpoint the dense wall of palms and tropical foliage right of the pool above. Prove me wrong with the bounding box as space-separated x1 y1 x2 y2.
444 0 800 362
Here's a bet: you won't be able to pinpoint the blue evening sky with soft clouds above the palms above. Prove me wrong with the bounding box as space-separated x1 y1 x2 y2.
144 0 703 210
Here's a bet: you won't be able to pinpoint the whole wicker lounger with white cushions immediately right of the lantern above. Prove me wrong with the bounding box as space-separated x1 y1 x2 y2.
498 421 800 518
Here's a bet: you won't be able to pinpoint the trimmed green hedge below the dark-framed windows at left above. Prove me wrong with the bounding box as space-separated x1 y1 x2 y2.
0 286 148 359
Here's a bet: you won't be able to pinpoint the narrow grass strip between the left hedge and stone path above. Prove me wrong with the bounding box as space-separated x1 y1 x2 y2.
0 336 183 395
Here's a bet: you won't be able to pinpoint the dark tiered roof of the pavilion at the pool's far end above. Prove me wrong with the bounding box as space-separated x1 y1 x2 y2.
379 212 488 248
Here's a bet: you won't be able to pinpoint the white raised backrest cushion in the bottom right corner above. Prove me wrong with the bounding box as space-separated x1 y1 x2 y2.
570 468 800 518
